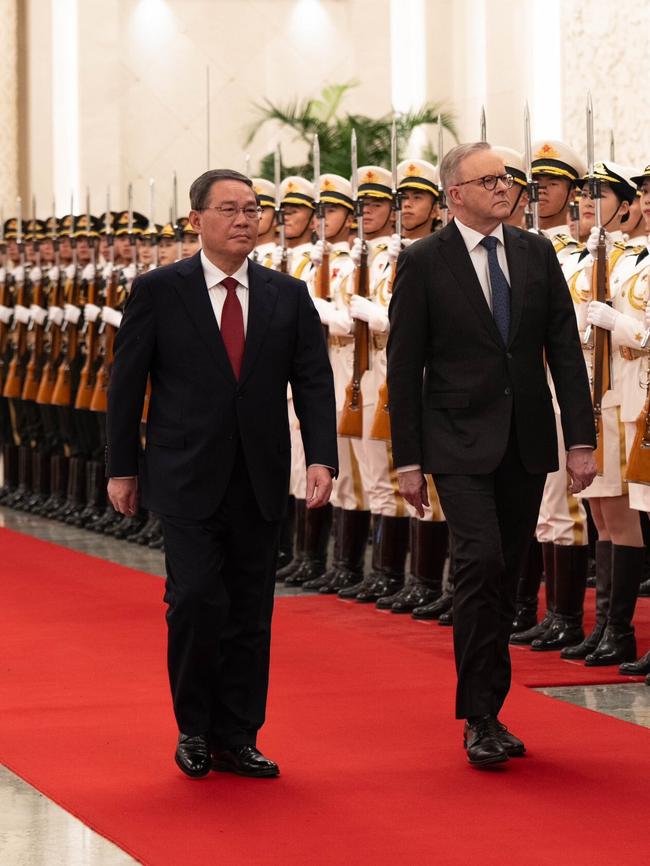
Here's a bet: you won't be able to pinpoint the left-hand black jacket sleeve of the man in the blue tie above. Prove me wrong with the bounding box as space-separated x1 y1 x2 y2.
387 250 429 468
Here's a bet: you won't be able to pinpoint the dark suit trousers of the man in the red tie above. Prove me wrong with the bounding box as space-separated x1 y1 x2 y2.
161 451 280 748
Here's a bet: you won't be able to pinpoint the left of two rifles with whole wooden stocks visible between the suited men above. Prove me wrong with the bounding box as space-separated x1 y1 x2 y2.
338 130 370 439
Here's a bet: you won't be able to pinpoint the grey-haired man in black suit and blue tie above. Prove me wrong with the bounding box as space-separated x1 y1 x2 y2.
388 142 595 766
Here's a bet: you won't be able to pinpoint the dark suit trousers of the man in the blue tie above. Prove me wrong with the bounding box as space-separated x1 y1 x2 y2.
434 431 546 719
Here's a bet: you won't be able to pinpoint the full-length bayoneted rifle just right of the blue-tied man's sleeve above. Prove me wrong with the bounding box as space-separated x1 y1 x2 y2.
584 94 611 475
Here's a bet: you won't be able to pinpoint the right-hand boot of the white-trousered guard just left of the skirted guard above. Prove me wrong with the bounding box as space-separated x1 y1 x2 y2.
530 544 589 652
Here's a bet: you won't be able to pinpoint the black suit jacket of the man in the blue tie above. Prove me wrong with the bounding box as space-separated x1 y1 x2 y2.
388 216 596 475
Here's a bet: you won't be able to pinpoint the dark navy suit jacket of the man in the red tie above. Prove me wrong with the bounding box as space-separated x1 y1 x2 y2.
107 254 338 520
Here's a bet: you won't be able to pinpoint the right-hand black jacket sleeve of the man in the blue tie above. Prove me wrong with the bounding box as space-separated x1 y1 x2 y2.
545 242 596 449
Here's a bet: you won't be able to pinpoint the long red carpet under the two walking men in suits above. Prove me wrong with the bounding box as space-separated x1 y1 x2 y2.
0 530 650 866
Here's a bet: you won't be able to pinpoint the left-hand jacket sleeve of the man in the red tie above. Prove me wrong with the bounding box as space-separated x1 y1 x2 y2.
106 279 155 478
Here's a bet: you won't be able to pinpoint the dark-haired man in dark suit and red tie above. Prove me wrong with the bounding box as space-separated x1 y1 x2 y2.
107 169 337 777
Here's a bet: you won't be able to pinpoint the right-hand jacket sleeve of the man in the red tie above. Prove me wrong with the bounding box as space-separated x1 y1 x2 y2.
289 283 339 473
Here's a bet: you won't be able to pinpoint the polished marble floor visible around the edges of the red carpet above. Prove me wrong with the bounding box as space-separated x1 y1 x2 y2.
0 507 650 866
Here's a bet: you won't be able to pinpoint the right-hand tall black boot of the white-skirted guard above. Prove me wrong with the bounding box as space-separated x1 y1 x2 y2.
585 544 645 667
